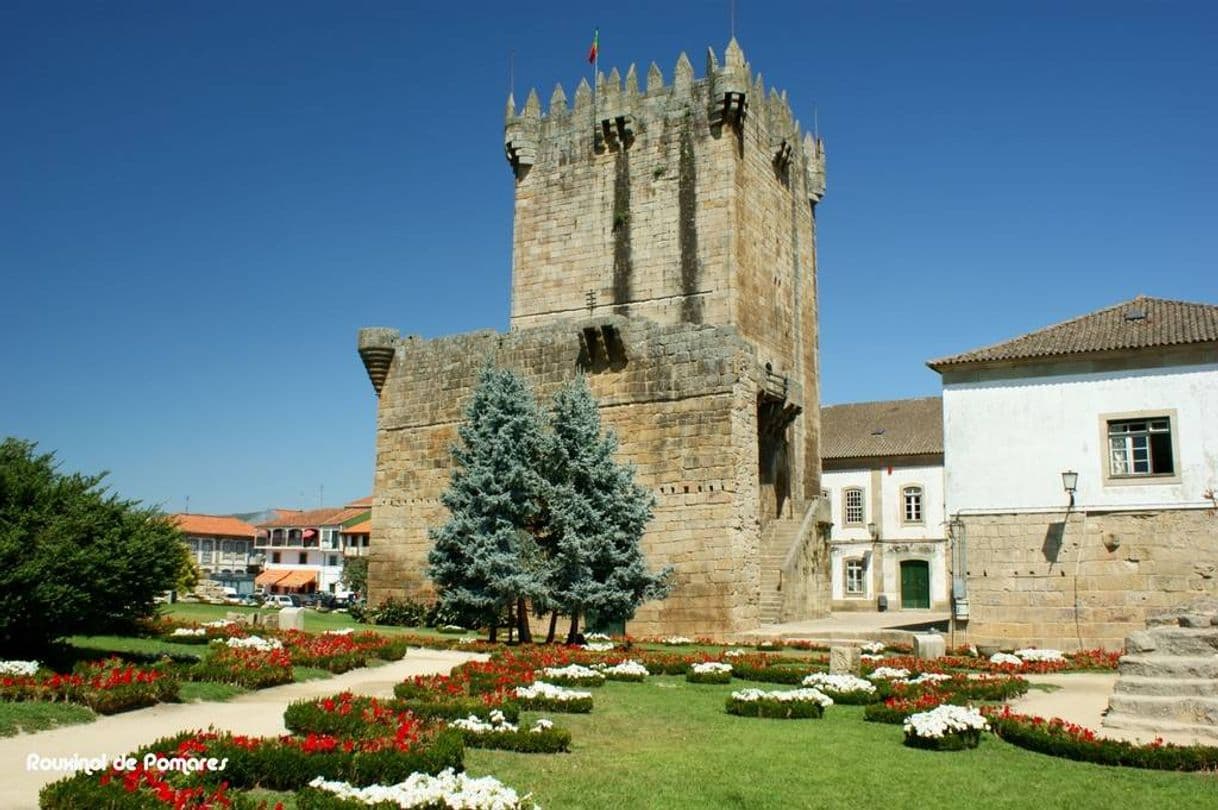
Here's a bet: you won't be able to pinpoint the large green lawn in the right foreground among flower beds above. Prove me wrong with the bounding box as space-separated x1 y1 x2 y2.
465 677 1218 810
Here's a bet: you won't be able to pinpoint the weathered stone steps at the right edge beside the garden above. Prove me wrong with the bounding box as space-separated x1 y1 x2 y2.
1104 614 1218 743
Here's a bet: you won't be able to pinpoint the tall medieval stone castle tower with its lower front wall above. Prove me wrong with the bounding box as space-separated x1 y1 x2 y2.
359 40 828 633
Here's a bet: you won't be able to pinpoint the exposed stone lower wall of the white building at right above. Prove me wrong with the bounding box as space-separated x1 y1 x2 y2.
957 509 1218 649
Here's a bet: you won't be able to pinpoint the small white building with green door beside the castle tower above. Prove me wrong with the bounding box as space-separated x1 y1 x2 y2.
821 397 949 610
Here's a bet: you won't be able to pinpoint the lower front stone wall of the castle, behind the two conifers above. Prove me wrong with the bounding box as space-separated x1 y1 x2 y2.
369 317 760 635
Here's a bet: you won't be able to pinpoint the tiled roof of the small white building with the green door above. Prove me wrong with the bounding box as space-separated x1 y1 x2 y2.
821 397 943 458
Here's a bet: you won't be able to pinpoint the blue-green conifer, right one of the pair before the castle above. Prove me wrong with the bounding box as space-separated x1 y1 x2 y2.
543 376 671 643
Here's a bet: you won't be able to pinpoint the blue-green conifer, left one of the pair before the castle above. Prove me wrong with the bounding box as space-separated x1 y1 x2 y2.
428 365 542 639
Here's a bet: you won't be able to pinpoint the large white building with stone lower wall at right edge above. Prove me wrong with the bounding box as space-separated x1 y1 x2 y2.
929 297 1218 647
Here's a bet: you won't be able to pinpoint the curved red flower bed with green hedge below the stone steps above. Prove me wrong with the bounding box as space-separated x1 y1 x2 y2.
985 706 1218 771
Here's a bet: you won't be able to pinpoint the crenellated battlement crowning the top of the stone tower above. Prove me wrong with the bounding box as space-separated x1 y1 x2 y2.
503 38 825 203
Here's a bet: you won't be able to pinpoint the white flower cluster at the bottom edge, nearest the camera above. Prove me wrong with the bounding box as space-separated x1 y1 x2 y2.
309 767 521 810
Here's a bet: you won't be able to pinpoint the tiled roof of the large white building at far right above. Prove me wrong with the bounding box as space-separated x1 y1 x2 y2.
927 296 1218 372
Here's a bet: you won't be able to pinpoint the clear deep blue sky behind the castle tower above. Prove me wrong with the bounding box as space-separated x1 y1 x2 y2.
0 0 1218 513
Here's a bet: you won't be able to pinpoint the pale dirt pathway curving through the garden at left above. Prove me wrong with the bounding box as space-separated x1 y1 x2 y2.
0 648 486 810
